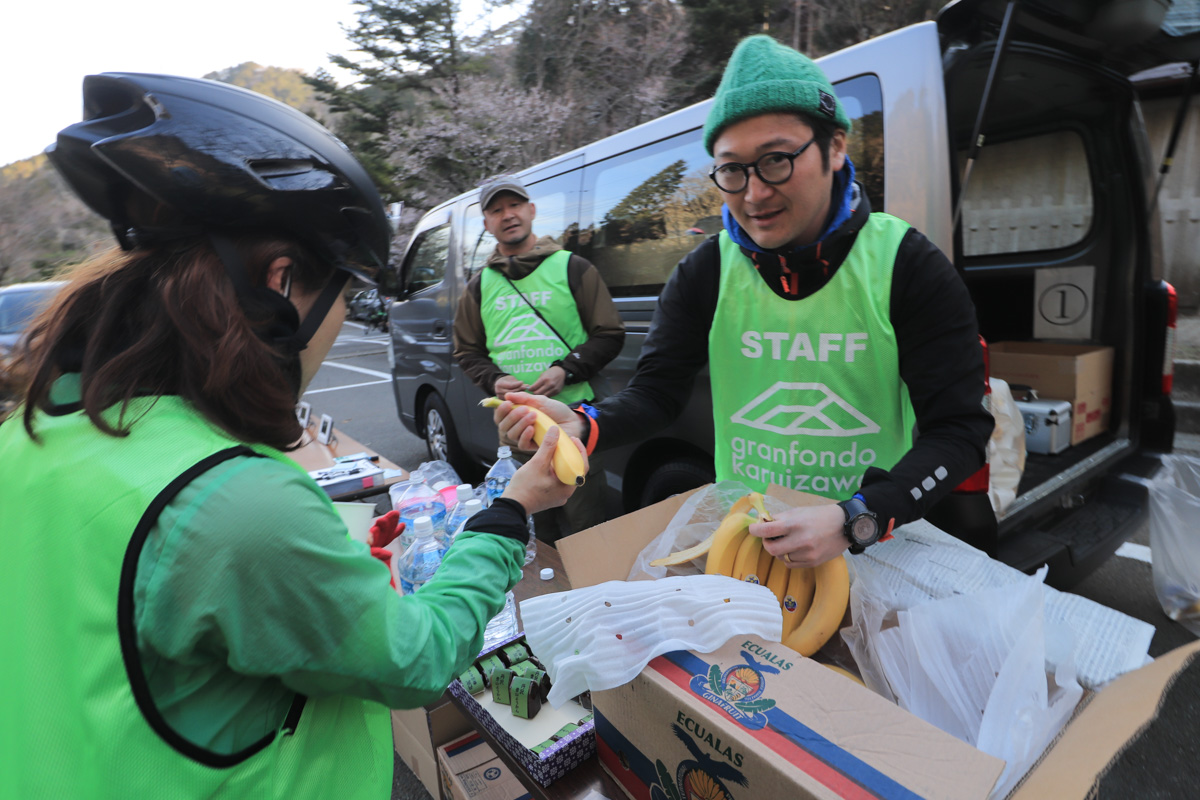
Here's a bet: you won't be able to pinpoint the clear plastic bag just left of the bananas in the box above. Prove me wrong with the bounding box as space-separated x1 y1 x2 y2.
628 481 787 581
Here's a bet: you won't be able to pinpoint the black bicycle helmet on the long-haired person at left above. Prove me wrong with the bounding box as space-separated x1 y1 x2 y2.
46 72 391 349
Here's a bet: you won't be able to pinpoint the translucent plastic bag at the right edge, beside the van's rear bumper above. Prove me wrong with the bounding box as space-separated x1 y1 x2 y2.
1145 455 1200 636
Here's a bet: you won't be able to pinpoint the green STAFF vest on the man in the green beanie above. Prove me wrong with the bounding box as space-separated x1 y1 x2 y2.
708 213 916 499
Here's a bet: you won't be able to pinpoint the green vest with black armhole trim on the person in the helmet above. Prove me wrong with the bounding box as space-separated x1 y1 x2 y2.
0 397 392 800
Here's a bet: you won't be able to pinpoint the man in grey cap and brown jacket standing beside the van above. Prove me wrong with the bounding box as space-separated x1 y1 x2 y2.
454 175 625 542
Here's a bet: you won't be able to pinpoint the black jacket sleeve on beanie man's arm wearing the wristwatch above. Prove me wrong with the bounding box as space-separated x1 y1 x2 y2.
862 229 994 528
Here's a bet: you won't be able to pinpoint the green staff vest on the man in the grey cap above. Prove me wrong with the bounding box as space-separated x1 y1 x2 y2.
479 249 594 404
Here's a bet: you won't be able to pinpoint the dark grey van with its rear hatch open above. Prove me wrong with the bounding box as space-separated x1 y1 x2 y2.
389 0 1200 585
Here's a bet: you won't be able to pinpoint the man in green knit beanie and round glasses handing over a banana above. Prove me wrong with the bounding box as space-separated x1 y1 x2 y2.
497 36 992 566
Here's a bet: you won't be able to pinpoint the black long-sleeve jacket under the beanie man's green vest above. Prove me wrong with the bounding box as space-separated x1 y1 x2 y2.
596 191 994 528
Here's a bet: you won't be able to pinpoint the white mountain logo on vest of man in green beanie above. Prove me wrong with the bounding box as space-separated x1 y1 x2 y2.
731 380 880 437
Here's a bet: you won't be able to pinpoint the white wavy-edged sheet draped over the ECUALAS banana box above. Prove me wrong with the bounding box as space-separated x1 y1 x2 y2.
521 575 784 708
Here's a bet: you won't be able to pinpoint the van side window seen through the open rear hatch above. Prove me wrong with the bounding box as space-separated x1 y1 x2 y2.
959 131 1093 255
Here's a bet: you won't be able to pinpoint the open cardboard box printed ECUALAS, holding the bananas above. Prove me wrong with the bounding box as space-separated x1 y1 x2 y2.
558 487 1200 800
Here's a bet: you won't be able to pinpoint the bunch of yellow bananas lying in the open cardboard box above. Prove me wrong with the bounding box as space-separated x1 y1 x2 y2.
650 492 850 656
